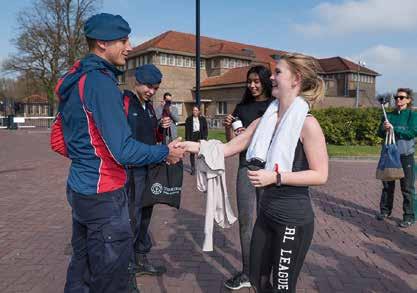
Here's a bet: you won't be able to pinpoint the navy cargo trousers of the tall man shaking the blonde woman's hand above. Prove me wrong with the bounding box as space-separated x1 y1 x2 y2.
64 187 134 293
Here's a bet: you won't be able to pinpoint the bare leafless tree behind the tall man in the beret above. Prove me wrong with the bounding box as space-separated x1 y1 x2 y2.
3 0 101 111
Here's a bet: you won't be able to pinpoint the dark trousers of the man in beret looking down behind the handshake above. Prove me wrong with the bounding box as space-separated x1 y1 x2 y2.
126 168 153 254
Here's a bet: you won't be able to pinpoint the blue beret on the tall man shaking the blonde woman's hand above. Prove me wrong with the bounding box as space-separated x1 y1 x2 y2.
84 13 132 41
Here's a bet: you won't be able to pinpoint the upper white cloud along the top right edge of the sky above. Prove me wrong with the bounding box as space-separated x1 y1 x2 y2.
294 0 417 37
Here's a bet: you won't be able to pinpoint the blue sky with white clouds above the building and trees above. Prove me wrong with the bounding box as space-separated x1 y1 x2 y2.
0 0 417 92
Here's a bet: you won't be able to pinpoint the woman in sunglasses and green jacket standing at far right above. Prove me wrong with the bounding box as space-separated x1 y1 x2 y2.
377 88 417 228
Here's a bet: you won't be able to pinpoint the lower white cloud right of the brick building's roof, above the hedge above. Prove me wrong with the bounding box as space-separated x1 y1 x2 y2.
352 45 417 92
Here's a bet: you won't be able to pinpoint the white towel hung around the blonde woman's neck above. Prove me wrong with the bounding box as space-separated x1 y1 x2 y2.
246 97 309 172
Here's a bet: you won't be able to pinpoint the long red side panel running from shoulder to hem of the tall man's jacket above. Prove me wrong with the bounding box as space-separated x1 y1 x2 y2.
78 75 127 193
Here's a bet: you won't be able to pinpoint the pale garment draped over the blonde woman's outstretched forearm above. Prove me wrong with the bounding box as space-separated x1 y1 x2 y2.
196 140 237 251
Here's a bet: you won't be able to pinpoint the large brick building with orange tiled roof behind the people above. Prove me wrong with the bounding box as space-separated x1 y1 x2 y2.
120 31 379 121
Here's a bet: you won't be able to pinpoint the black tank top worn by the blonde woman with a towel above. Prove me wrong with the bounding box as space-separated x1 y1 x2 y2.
259 140 314 226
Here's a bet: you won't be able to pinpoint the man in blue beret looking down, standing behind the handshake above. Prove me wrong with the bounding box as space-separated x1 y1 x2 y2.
124 64 169 275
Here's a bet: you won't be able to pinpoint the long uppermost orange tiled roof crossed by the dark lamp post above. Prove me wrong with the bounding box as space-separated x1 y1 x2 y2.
130 31 284 64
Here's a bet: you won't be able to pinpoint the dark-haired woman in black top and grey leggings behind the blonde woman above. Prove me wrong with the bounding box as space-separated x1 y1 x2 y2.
221 65 272 290
